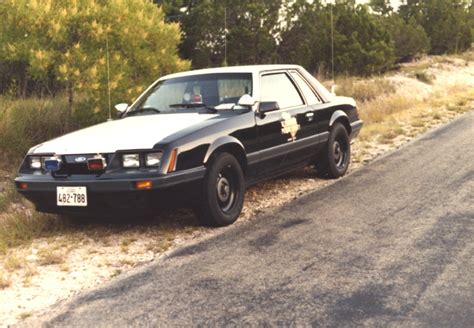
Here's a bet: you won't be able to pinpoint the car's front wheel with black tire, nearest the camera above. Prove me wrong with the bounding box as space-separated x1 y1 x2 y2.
194 153 245 227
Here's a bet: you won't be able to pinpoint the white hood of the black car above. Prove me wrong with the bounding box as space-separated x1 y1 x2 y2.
29 113 217 155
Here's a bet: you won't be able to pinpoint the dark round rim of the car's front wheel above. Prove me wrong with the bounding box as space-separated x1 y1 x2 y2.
216 165 237 213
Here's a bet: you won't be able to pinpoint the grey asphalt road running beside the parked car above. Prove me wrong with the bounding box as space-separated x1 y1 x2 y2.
37 112 474 327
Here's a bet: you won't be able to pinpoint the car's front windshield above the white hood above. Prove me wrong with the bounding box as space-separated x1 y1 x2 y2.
127 73 252 116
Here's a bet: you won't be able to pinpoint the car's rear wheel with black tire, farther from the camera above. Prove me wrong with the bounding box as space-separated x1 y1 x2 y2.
316 122 351 179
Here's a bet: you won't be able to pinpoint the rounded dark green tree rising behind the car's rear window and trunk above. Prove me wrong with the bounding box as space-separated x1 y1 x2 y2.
279 1 394 75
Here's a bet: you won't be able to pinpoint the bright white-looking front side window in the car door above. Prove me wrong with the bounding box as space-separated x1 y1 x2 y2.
260 73 304 108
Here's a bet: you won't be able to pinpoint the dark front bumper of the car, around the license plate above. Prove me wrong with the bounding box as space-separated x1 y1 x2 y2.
15 166 206 215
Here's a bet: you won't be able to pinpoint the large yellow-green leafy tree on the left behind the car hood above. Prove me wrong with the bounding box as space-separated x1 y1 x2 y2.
0 0 189 124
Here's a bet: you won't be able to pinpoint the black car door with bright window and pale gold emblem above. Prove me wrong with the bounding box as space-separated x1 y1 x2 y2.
256 71 314 177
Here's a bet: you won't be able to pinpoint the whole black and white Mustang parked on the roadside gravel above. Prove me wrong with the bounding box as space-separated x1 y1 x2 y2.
15 65 362 225
